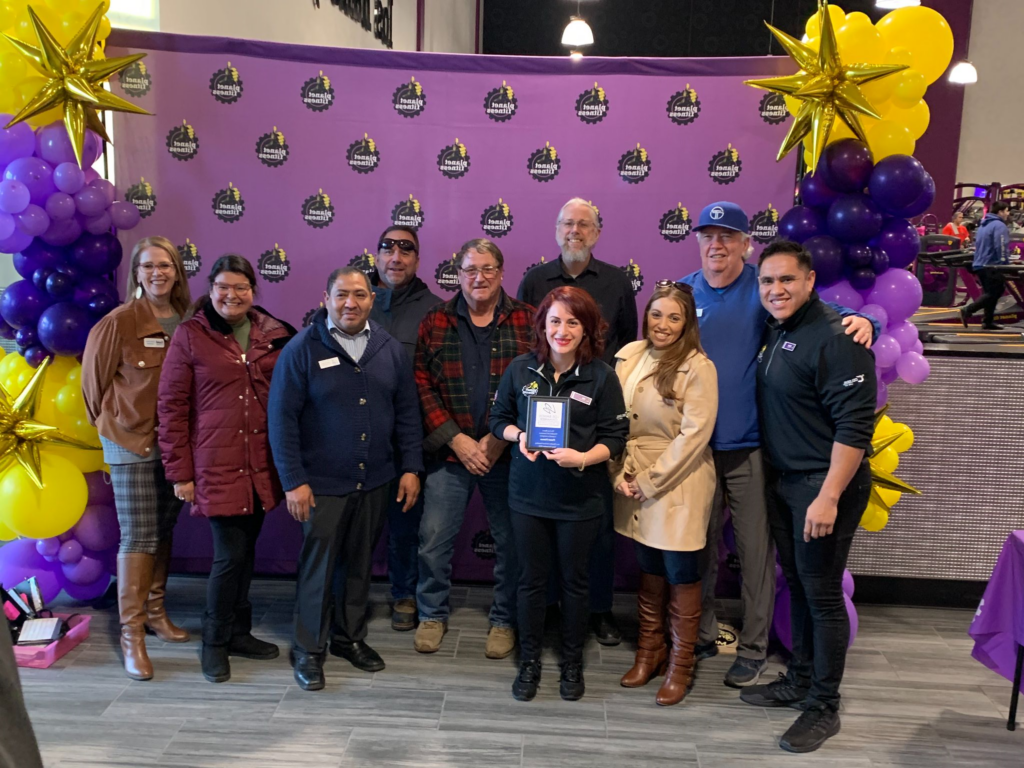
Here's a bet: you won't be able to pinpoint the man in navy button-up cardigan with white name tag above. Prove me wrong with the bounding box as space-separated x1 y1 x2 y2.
267 267 423 690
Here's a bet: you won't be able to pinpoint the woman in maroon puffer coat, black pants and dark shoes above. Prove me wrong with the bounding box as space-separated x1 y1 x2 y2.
157 255 295 683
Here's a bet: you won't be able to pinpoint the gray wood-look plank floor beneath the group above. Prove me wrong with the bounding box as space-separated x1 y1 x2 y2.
22 579 1024 768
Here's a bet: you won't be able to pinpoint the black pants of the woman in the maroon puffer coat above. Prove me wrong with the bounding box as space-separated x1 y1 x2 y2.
203 499 266 645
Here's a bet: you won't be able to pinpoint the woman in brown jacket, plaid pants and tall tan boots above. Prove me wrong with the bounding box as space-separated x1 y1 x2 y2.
82 238 191 680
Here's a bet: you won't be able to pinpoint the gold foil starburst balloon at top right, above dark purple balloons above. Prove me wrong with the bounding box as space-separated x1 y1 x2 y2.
745 0 906 173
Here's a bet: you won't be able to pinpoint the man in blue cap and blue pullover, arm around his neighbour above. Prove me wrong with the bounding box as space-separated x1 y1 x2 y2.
682 202 873 688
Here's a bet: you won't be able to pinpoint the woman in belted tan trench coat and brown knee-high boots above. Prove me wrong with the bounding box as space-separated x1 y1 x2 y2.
609 281 718 706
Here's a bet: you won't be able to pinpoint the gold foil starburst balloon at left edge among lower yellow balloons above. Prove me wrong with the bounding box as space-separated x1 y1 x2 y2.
0 357 99 488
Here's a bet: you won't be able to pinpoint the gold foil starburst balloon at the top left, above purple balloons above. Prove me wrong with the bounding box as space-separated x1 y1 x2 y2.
4 5 150 166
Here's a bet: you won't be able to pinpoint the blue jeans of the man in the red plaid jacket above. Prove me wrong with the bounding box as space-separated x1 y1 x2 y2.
416 462 518 627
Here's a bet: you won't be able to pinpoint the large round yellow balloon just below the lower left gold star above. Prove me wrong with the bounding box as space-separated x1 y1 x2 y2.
0 452 89 539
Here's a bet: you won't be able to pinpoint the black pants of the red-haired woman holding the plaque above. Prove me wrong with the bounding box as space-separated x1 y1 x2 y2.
512 510 603 663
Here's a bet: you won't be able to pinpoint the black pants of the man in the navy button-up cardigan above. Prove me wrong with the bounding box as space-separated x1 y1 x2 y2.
295 483 391 653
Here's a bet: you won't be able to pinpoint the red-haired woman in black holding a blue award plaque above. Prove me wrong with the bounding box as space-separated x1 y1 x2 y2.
490 287 629 701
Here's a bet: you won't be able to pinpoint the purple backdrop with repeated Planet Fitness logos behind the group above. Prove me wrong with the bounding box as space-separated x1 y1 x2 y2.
109 31 795 580
